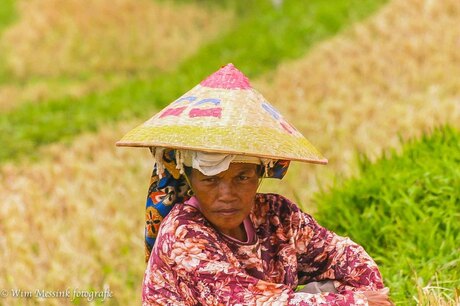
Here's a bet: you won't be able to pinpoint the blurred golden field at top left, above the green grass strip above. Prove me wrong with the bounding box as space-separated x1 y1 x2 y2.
0 0 233 110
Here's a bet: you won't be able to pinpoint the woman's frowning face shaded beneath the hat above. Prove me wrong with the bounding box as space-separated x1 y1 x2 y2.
190 163 259 240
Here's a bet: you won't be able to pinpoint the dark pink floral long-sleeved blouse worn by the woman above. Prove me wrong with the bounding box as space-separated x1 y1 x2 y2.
142 194 384 305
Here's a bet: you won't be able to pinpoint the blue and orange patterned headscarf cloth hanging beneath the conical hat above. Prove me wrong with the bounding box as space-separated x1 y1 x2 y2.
145 149 290 262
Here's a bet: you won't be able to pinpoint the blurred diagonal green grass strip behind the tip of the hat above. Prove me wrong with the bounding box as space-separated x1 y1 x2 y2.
0 0 386 163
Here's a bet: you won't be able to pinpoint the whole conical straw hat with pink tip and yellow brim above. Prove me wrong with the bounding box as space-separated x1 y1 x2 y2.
117 64 327 164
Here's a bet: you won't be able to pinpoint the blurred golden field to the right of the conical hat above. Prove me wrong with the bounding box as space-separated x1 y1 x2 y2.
255 0 460 207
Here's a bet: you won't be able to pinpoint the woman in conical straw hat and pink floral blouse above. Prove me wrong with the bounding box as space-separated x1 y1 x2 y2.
118 65 391 305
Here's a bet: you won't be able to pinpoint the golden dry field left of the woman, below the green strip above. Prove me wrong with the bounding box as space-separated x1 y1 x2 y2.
0 123 152 305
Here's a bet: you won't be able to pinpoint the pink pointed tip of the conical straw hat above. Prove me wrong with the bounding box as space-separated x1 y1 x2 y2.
200 64 251 89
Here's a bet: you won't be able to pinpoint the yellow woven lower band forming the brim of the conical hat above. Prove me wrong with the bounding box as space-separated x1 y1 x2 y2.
117 126 328 164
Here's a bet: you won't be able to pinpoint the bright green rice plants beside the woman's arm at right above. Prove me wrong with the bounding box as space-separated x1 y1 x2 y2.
315 126 460 305
